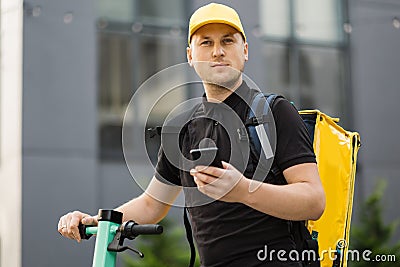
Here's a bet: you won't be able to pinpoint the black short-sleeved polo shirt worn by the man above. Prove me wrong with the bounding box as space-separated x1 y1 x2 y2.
155 82 316 267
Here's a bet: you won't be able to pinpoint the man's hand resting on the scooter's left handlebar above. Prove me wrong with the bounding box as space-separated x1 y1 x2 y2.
58 211 98 242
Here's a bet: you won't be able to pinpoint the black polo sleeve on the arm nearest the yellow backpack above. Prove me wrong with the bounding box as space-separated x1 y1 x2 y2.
272 98 316 171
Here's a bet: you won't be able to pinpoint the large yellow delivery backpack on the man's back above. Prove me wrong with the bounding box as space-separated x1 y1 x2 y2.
299 110 360 267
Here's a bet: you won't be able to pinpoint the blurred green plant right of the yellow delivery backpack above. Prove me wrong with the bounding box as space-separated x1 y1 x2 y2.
349 180 400 267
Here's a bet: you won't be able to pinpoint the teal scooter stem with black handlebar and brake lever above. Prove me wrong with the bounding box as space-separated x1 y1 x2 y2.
79 210 163 267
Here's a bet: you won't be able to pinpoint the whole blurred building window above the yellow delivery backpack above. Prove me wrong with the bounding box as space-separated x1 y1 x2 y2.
259 0 348 119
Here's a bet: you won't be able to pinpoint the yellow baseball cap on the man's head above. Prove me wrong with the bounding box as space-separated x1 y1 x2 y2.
188 3 246 45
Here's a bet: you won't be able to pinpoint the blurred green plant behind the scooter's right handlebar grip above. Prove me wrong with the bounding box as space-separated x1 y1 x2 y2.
123 218 200 267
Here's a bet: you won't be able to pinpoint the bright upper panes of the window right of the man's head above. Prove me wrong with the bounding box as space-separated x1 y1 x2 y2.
259 0 343 44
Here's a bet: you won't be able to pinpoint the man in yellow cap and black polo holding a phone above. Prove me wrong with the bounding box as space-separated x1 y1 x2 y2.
58 3 325 267
